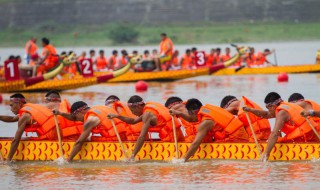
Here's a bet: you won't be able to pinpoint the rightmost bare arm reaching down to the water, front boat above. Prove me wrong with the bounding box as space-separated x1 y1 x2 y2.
262 110 290 160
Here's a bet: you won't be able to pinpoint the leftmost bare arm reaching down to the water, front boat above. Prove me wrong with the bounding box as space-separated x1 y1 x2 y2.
7 113 31 162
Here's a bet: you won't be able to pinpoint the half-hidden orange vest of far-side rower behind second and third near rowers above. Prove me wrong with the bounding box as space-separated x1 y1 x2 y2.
113 101 143 141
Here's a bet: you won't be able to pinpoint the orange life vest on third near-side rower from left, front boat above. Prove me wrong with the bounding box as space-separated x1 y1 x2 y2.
143 102 184 142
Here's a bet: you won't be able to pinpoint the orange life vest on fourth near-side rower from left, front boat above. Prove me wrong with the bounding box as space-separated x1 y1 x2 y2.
198 104 249 142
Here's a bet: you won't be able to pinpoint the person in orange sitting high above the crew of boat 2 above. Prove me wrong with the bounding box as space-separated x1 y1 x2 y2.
154 33 174 71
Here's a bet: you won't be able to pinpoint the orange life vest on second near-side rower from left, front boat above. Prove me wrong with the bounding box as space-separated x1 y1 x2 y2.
84 106 126 141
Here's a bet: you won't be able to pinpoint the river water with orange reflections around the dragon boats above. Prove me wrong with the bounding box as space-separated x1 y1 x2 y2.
0 42 320 189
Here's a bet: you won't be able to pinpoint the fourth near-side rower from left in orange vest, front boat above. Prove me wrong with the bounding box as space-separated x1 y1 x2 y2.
170 98 249 161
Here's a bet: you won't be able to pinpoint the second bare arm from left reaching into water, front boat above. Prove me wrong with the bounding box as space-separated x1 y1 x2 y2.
68 116 100 162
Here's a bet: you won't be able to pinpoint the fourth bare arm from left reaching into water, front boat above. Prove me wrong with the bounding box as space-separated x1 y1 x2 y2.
183 120 214 162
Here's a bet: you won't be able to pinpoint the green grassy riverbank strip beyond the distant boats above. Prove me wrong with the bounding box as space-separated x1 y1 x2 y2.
0 23 320 47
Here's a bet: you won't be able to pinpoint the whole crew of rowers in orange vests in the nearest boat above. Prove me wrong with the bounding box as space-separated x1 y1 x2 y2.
0 91 320 161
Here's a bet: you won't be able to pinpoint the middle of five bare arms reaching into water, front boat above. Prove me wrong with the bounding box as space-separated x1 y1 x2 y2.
130 112 157 160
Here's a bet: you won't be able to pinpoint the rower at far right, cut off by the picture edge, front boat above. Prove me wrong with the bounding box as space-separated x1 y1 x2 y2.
288 93 320 125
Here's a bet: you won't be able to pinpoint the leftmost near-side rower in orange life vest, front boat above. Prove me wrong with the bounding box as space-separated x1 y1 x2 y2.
7 94 57 162
